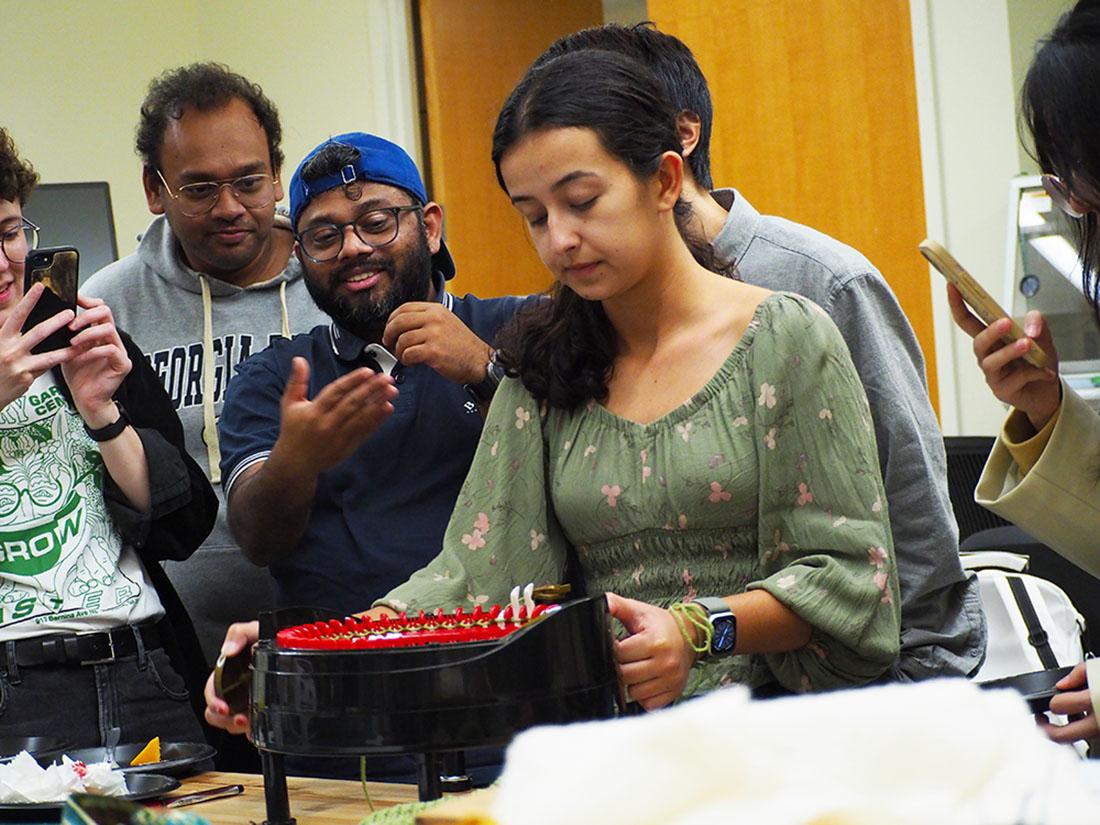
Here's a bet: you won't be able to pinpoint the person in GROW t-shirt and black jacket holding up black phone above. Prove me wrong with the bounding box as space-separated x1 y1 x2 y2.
0 129 217 747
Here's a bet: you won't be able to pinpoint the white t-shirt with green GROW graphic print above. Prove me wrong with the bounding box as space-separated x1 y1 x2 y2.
0 372 164 641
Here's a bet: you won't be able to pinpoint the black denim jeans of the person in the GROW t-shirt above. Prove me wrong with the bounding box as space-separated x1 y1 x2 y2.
0 642 205 748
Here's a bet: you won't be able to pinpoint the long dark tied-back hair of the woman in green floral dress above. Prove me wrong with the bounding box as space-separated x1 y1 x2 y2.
493 50 733 409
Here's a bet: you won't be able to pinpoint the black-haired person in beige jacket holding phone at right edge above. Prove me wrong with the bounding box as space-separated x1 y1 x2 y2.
947 0 1100 741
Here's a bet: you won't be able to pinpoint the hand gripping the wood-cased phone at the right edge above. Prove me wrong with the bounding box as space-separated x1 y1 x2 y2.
947 284 1062 431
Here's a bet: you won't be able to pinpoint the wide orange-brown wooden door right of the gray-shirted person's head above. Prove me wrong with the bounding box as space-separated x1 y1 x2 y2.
649 0 938 409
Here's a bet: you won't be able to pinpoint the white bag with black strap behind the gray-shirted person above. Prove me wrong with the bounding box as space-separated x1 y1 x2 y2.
960 550 1085 682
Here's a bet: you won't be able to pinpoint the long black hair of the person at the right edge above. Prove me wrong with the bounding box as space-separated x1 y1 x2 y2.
1021 0 1100 319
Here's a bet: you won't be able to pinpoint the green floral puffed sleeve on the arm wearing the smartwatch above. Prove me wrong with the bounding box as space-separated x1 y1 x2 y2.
749 296 900 691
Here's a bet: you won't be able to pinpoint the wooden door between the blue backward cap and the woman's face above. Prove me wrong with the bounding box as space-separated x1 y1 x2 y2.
417 0 603 297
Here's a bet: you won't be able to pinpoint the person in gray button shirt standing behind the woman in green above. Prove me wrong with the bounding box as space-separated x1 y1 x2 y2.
538 23 986 681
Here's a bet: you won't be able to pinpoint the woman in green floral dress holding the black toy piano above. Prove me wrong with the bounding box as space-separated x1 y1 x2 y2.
378 52 899 708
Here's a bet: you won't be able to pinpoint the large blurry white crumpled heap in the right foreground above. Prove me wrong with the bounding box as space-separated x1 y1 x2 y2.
492 680 1100 825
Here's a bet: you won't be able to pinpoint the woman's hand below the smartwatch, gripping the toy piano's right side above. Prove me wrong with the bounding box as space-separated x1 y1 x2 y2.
607 593 695 711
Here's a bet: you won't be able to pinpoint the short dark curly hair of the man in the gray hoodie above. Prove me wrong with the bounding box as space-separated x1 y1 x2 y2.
136 63 283 174
